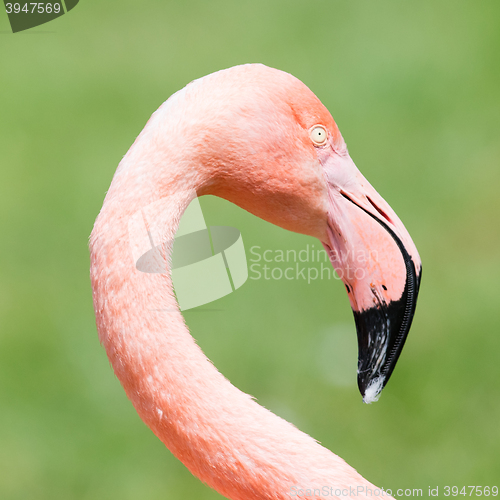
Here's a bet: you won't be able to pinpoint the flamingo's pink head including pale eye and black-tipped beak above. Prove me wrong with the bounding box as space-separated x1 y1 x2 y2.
172 65 421 403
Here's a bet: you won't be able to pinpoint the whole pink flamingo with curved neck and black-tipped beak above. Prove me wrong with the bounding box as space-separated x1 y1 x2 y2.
90 64 421 500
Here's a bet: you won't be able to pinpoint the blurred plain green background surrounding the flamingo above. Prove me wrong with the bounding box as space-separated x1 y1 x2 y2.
0 0 500 500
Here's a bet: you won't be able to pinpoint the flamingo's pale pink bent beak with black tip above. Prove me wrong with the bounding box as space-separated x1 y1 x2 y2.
318 148 422 403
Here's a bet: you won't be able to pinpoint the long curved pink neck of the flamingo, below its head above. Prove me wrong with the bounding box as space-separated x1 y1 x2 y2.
90 125 375 500
